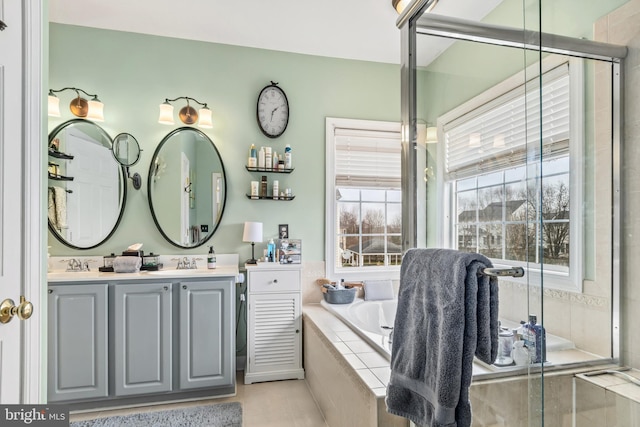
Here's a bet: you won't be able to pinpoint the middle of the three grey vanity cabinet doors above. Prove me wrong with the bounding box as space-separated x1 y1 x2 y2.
113 283 171 396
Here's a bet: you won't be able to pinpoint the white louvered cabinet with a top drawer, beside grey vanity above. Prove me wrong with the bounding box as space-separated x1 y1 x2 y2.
244 263 304 384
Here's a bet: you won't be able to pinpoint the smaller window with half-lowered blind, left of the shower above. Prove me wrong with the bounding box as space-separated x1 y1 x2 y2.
326 118 402 279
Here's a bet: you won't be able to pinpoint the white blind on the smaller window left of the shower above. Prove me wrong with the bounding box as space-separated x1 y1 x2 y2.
334 128 400 188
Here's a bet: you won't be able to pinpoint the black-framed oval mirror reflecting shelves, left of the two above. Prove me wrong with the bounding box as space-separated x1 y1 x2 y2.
48 119 127 249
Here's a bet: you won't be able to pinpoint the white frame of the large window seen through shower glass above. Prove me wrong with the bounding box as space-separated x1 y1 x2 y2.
436 56 585 293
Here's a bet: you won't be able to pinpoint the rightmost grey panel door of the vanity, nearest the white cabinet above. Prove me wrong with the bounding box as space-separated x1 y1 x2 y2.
179 280 235 389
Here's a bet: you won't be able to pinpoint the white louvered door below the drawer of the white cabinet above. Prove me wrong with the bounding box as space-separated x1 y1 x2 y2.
245 293 302 383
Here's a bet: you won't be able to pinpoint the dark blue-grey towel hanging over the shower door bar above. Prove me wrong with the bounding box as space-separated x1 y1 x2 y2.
386 249 499 427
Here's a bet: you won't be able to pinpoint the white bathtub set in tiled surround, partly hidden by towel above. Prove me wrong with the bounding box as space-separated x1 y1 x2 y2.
320 298 575 377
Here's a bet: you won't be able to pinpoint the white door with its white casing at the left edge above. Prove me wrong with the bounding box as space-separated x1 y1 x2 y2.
0 0 46 404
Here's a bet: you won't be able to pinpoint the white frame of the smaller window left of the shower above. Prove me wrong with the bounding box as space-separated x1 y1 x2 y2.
325 117 401 281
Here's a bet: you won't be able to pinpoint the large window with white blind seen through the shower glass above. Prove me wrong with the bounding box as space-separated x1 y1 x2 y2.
439 59 582 291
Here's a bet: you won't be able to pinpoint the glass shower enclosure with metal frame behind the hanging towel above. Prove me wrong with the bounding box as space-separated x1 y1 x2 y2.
400 1 624 426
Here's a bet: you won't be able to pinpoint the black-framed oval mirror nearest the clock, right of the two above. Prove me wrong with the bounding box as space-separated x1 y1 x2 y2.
147 127 227 249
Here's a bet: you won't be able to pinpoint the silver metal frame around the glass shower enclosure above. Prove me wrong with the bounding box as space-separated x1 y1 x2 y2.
396 0 627 363
